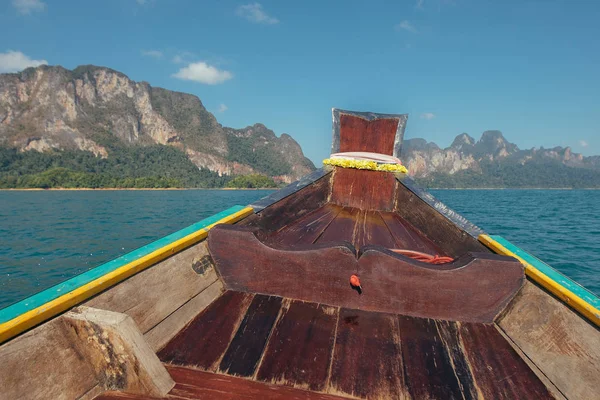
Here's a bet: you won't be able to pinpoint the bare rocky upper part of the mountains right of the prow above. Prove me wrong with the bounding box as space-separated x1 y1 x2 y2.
402 131 600 178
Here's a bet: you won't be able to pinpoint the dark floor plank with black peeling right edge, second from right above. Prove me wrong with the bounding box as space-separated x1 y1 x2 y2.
398 315 476 399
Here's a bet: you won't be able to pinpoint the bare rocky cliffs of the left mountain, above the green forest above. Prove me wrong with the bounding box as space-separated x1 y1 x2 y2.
0 66 315 182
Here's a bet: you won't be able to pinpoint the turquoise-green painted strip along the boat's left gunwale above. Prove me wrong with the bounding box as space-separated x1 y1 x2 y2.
0 206 246 324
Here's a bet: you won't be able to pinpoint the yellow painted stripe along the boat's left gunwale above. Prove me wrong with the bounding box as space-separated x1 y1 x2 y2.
0 207 254 343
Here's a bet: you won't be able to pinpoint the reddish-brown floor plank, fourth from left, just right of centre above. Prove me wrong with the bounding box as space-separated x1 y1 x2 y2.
328 308 408 399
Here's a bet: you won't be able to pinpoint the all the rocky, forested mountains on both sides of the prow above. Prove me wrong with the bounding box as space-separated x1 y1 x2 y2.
0 65 600 188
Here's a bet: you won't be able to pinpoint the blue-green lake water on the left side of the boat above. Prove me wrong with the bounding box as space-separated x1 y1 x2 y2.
0 190 272 308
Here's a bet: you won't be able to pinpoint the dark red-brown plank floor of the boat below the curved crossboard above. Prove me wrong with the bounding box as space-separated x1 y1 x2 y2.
100 291 553 399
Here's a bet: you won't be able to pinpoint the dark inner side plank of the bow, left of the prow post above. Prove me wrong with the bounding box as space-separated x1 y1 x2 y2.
238 174 332 232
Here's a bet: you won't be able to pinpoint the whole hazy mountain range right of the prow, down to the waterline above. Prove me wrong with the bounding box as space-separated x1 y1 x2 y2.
402 131 600 188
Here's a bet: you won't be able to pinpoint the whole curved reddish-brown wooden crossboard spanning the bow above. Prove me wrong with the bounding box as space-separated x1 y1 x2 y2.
208 226 524 322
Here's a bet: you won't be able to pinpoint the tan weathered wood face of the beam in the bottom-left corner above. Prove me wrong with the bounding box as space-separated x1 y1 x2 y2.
0 318 98 400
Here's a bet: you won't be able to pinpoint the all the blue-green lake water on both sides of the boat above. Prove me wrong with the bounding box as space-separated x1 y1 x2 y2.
0 190 600 308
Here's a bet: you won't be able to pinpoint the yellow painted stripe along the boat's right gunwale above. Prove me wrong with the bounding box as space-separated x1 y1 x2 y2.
479 234 600 327
